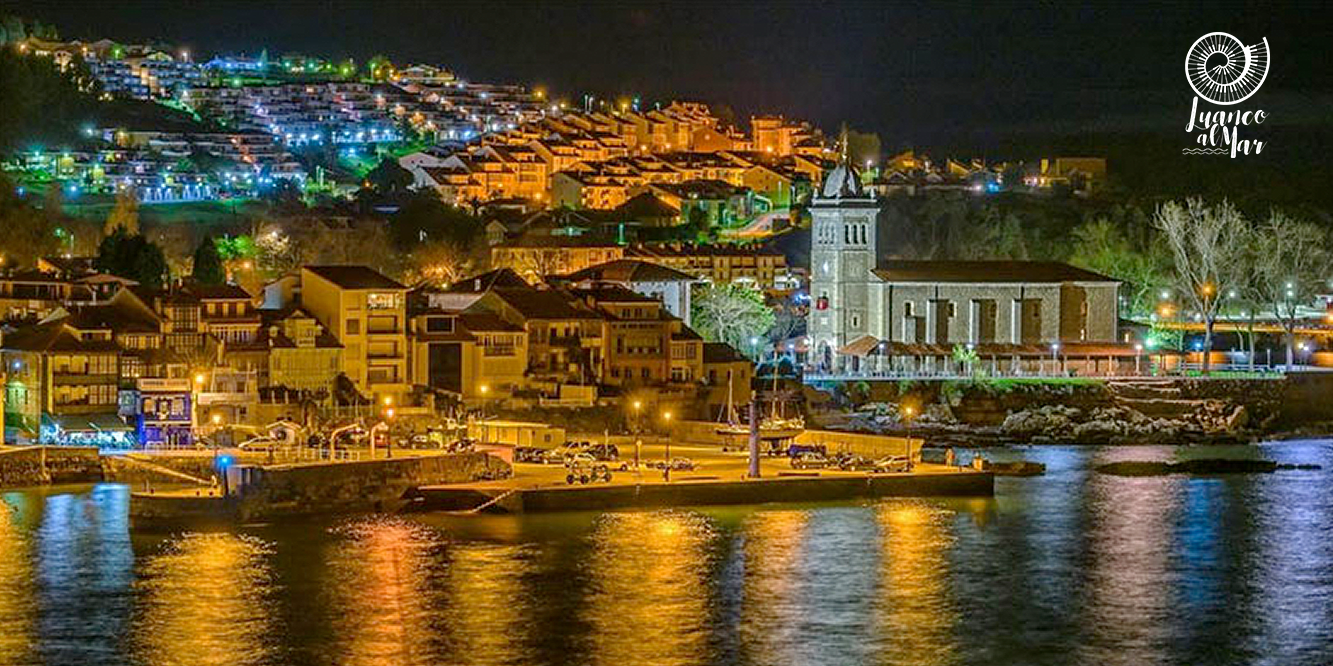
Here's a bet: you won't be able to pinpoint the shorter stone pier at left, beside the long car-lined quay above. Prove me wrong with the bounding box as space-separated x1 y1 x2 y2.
129 453 512 529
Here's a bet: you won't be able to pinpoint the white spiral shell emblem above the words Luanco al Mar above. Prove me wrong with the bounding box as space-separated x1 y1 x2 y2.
1185 32 1268 107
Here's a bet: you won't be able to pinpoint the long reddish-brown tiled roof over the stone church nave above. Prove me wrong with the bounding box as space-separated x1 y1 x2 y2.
874 261 1118 282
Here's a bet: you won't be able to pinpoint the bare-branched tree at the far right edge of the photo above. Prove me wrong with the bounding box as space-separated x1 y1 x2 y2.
1252 210 1333 372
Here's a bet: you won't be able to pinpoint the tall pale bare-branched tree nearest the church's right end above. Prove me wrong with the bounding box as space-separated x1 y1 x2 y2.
1153 198 1250 373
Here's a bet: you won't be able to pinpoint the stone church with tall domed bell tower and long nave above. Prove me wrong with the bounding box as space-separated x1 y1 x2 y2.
806 159 1133 374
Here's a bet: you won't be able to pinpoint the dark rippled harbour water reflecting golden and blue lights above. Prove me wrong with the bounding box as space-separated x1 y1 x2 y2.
0 441 1333 666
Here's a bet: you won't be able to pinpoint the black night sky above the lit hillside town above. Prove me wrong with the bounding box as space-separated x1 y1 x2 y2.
10 0 1333 148
